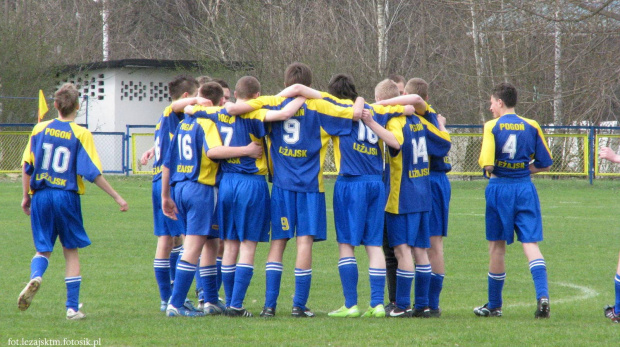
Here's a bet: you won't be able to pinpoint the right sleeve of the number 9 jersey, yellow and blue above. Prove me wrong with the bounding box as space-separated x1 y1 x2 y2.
306 99 353 136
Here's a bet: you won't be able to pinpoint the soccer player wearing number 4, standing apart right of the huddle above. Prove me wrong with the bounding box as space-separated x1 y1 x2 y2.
474 83 553 318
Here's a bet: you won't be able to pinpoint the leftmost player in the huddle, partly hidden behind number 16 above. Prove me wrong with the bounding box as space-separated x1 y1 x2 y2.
141 75 199 312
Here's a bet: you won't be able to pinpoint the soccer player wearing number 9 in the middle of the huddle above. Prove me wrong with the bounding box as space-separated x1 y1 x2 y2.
227 63 353 317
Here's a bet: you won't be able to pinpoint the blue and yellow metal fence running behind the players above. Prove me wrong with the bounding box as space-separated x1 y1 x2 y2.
0 124 620 182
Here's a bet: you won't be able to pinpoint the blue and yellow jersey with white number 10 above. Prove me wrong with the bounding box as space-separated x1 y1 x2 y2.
22 119 102 194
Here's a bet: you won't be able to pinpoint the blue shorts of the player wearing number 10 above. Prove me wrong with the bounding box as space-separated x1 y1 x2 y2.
30 188 90 252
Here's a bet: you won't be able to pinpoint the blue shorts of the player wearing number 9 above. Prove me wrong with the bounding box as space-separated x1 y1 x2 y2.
271 186 327 241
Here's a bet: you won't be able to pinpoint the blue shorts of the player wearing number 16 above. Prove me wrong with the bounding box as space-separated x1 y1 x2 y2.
174 181 220 238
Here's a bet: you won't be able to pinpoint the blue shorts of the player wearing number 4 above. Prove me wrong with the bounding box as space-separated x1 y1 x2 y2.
485 177 543 244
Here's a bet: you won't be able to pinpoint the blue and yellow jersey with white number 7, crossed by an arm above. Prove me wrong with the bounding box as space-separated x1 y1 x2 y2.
189 105 268 175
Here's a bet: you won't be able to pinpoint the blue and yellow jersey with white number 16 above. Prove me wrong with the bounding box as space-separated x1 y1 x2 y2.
163 117 222 186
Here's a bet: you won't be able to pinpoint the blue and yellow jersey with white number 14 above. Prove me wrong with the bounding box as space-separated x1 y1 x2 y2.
385 115 451 214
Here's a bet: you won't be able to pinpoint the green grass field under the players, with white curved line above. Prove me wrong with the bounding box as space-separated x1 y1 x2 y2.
0 176 620 346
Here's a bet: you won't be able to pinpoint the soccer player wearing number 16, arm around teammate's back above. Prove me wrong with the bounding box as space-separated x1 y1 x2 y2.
161 84 262 317
